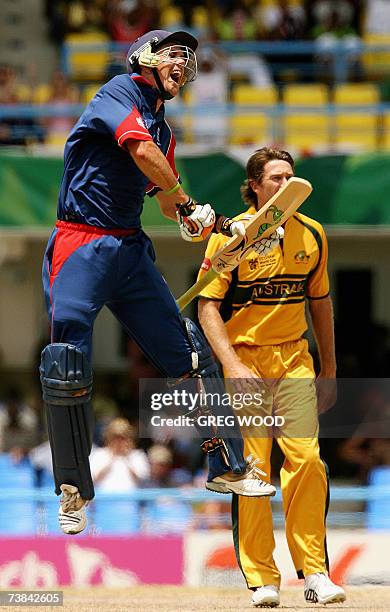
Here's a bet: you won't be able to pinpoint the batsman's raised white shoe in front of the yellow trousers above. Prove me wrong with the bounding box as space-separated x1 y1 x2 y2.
206 455 276 497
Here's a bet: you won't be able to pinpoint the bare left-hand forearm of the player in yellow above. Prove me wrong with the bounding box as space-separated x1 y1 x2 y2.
198 297 256 379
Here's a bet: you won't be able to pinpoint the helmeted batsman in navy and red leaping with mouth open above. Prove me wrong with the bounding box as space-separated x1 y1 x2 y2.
40 30 275 534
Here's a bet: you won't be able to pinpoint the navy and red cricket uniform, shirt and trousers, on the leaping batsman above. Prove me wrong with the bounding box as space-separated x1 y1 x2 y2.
43 74 192 377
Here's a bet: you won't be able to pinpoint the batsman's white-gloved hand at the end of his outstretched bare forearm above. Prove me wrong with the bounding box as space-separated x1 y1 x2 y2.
176 198 215 242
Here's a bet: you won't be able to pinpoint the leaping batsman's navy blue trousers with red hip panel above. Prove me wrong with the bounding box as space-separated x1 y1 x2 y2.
43 222 236 480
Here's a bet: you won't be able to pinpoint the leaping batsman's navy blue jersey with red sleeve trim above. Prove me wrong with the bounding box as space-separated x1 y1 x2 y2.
57 74 178 228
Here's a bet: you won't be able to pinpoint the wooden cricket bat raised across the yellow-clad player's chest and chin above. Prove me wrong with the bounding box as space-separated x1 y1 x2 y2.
177 176 313 310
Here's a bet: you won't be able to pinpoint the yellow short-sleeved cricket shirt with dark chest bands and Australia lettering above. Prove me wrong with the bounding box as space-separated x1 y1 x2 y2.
198 207 329 346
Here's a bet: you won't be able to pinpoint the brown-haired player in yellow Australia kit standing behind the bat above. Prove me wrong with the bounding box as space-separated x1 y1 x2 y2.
199 148 345 607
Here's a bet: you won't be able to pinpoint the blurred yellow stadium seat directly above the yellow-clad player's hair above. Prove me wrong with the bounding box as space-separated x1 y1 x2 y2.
229 113 273 145
